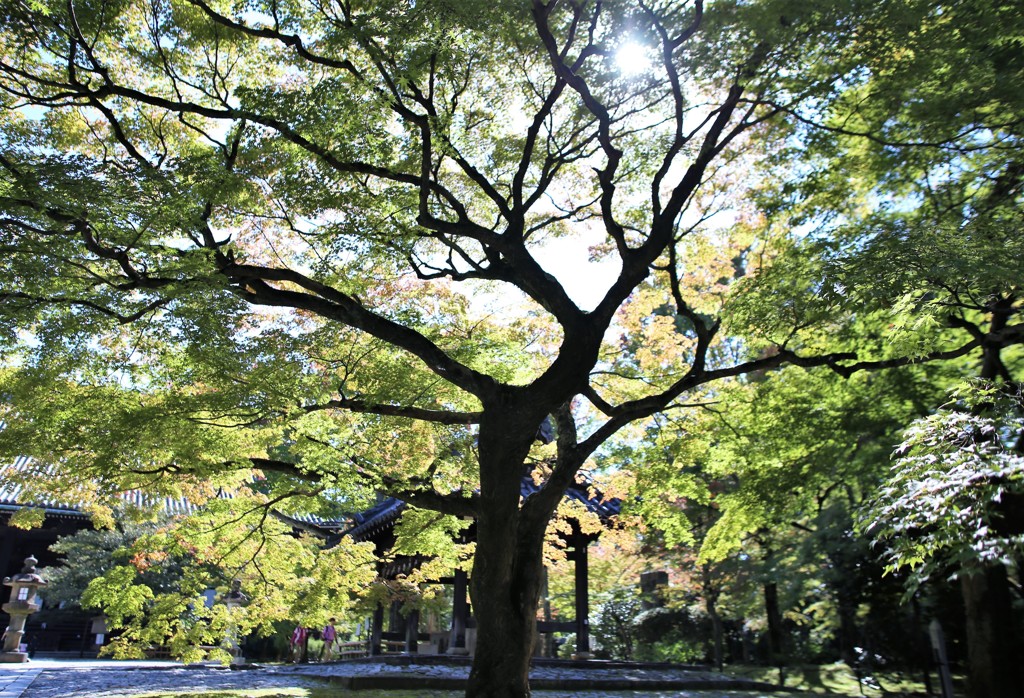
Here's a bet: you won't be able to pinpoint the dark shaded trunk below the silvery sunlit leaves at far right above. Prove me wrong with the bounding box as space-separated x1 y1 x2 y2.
961 567 1024 698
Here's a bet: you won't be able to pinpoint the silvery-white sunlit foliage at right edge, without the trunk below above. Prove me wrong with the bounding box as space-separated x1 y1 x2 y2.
864 384 1024 588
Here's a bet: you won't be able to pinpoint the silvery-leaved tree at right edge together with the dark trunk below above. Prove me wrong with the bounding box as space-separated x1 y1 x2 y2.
864 384 1024 696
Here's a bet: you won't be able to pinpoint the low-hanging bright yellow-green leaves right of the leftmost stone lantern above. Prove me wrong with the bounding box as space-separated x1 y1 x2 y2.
76 495 376 661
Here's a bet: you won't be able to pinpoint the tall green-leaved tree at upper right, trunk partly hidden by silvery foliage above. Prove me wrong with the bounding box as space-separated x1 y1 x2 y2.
712 0 1024 698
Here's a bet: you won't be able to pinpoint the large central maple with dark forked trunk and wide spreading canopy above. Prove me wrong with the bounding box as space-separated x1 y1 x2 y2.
0 0 1021 696
